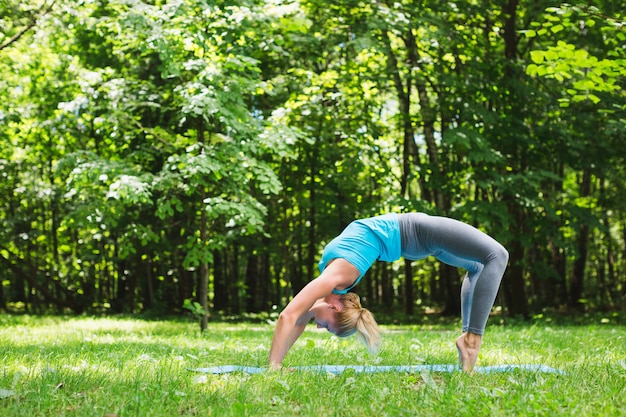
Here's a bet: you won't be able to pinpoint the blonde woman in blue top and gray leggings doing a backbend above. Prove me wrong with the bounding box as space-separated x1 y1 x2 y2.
269 213 509 372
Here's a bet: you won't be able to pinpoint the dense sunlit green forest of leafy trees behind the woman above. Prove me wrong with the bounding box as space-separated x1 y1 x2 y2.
0 0 626 326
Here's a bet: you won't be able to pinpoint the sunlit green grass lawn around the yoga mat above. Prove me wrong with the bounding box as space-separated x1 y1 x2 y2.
0 316 626 417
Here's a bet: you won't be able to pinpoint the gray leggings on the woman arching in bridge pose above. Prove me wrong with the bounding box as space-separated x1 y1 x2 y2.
398 213 509 335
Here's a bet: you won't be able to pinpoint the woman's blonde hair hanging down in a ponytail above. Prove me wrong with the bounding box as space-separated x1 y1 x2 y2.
336 292 380 354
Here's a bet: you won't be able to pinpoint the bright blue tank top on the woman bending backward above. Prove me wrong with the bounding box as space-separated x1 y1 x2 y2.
318 213 402 294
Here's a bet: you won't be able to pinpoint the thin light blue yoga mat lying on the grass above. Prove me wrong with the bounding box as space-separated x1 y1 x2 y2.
189 364 563 375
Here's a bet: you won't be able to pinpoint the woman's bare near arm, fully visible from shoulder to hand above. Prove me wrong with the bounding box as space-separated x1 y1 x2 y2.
269 259 359 368
